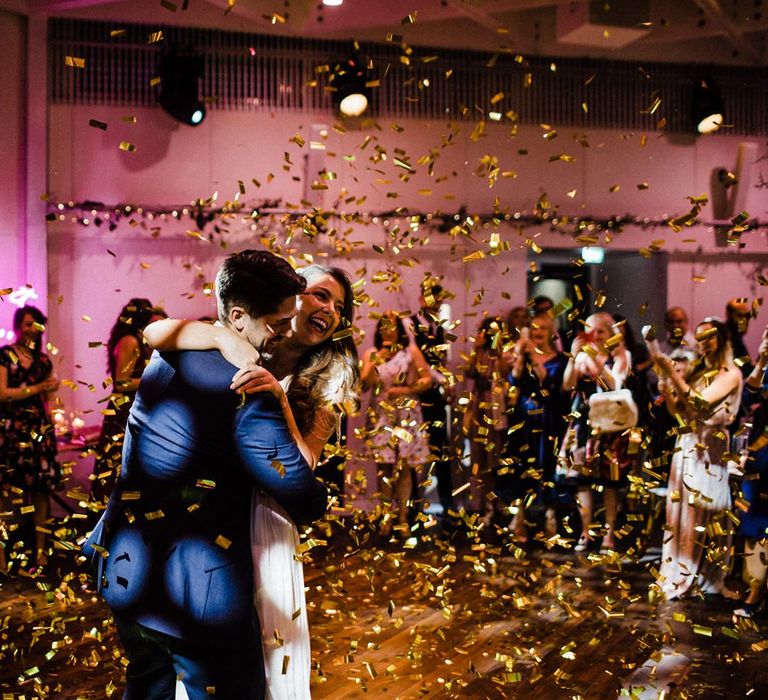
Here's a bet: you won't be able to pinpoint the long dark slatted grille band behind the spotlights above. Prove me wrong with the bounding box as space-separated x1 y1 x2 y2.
49 19 768 136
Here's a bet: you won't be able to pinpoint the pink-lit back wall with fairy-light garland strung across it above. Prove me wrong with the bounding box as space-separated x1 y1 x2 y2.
43 105 768 418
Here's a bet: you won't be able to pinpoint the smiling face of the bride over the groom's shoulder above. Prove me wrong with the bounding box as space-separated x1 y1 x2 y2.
293 273 344 347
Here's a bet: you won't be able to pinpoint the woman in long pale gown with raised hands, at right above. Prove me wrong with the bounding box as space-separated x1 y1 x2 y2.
656 318 742 599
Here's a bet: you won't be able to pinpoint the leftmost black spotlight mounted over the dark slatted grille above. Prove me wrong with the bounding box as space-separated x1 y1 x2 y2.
160 47 206 126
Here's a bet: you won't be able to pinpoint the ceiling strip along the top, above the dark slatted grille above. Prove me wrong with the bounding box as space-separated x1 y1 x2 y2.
6 0 768 65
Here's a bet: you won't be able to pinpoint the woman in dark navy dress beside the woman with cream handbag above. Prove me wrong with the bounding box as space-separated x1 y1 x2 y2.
505 314 568 542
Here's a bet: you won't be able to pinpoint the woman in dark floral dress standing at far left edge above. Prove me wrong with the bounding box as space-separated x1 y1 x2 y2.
0 306 61 571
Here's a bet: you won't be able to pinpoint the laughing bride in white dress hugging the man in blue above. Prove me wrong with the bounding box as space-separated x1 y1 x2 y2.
144 265 360 700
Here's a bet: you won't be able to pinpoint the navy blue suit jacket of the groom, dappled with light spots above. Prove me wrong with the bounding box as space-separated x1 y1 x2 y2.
85 351 327 644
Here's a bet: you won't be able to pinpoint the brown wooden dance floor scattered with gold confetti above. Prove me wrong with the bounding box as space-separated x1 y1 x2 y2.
0 522 768 700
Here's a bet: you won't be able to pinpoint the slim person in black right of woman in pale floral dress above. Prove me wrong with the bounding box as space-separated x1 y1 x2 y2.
411 278 453 519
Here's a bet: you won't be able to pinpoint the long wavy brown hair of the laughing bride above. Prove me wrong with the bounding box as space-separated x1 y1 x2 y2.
288 265 360 433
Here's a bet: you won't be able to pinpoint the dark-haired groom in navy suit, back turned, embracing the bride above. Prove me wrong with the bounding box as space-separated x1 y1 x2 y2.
85 250 327 700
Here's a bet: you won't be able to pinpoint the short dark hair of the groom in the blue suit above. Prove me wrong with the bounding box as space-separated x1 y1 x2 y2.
216 250 307 323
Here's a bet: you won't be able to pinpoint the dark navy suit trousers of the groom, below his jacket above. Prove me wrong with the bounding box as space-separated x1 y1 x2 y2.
115 616 265 700
